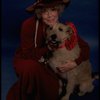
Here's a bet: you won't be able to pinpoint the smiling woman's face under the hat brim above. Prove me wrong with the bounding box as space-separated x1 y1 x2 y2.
41 8 59 27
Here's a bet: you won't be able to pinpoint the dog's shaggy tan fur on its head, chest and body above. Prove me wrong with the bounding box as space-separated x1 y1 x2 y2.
47 23 94 100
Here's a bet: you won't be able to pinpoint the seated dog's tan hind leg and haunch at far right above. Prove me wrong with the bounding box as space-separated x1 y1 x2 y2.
78 60 94 96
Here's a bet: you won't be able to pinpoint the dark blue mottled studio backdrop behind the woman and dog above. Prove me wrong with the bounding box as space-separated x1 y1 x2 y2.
1 0 99 100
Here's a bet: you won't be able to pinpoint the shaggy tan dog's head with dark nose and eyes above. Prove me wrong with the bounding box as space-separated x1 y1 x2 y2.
46 23 72 46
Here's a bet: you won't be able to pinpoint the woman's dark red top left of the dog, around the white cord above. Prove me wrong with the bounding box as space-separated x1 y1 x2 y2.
14 17 48 59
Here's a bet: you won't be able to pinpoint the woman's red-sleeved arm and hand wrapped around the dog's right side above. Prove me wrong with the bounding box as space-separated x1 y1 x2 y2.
58 22 90 72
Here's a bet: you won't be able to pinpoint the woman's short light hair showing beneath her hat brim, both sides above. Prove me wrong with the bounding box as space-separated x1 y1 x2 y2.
35 4 65 19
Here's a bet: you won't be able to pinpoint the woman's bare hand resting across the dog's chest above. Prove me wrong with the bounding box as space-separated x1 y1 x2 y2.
57 60 77 73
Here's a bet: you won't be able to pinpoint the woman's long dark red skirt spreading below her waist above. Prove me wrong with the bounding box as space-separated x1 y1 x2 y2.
7 59 59 100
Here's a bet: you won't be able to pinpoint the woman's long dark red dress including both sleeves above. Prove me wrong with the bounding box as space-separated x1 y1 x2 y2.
7 17 89 100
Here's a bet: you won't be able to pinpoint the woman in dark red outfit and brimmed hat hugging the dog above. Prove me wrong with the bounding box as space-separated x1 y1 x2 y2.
7 0 89 100
